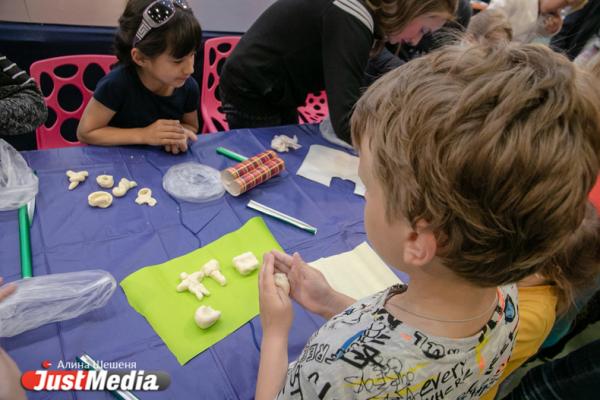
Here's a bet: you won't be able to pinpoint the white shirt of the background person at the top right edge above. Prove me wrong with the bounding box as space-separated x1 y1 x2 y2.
488 0 540 43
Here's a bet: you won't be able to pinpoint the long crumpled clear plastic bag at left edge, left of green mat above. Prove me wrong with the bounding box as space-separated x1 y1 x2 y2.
0 270 117 337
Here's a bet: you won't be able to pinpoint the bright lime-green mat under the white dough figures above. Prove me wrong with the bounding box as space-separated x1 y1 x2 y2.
121 217 281 365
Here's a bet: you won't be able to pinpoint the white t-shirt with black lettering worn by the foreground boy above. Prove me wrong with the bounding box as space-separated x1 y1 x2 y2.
277 285 518 399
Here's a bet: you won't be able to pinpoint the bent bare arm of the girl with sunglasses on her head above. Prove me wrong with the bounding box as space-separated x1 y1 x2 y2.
77 98 185 146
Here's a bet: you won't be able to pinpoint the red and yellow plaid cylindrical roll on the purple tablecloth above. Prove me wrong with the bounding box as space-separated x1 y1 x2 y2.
221 150 285 196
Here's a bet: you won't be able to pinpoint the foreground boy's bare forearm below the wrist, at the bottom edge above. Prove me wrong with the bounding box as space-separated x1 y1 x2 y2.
256 335 288 400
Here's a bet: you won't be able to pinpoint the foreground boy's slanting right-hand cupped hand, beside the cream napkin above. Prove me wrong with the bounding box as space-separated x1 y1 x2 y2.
271 250 354 318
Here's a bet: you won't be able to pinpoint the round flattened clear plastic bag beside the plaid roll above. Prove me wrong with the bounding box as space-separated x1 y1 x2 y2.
163 162 225 203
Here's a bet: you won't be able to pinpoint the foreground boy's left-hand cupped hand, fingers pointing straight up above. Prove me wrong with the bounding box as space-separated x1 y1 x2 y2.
258 253 294 338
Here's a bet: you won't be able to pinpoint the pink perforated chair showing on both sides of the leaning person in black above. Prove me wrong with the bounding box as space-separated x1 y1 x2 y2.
200 36 329 133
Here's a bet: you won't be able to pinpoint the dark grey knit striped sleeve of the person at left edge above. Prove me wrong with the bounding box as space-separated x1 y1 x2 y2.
0 53 48 136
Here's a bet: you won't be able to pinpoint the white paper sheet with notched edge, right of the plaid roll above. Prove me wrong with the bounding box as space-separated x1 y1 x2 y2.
296 144 365 196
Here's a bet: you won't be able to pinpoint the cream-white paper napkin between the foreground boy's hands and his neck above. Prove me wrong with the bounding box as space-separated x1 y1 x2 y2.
309 242 402 299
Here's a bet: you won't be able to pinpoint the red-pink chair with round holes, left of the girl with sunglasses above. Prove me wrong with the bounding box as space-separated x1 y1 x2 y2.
29 54 117 150
